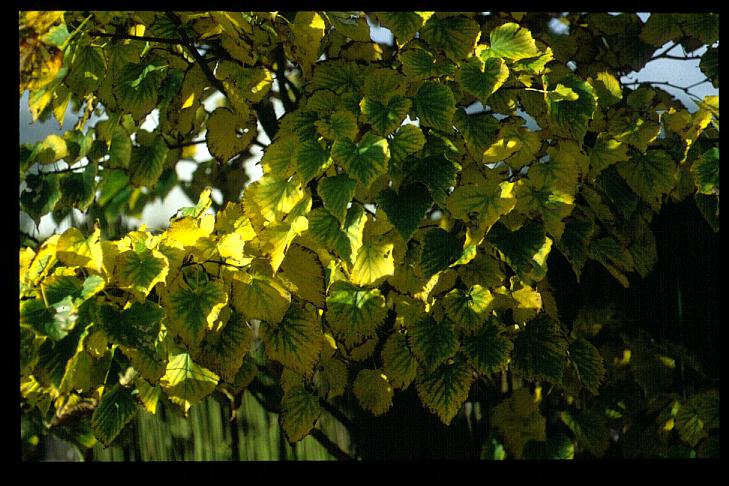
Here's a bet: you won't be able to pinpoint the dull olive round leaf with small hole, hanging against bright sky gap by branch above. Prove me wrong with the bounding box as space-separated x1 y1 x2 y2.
205 107 255 163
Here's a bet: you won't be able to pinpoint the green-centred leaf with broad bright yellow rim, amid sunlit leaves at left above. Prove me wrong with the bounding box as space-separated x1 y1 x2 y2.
114 249 169 301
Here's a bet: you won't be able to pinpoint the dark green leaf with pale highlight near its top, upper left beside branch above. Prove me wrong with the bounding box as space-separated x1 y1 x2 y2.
114 63 167 120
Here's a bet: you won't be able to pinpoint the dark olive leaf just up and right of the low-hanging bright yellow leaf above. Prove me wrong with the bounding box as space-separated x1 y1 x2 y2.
198 312 253 383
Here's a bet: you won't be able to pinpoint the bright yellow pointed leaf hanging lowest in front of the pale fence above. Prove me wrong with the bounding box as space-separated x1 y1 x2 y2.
160 351 219 413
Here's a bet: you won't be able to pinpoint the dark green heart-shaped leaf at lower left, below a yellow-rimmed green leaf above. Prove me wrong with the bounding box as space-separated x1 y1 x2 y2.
98 301 165 354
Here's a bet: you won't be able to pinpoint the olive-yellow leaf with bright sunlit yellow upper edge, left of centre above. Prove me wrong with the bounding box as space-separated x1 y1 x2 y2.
230 272 291 323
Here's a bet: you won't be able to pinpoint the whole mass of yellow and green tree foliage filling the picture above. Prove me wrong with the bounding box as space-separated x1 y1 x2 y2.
19 11 719 458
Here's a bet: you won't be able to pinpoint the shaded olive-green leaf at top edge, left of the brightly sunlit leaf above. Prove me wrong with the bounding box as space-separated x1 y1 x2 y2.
420 15 481 61
